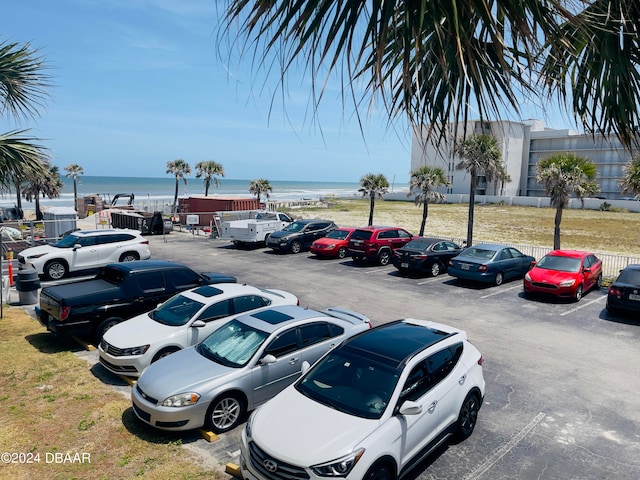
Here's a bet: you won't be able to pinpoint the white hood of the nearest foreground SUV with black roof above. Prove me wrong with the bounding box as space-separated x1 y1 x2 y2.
251 386 380 466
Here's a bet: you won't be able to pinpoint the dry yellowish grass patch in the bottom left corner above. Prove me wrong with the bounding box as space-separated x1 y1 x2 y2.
0 306 222 480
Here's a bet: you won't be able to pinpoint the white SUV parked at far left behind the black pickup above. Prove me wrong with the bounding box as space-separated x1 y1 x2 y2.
18 229 151 280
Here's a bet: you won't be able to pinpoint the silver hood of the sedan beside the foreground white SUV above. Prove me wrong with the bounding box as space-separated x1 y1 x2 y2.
138 347 238 402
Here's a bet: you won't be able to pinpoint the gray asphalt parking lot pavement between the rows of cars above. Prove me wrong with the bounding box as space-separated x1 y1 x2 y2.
28 232 640 480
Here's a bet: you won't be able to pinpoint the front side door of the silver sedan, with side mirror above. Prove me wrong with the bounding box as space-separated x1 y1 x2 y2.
251 327 302 407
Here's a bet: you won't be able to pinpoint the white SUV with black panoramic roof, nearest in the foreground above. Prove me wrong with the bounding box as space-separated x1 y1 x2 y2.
240 319 485 480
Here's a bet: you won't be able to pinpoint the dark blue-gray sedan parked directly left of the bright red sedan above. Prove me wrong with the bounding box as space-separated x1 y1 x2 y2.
447 243 536 285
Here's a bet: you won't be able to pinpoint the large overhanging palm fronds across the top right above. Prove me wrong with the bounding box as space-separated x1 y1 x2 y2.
220 0 640 152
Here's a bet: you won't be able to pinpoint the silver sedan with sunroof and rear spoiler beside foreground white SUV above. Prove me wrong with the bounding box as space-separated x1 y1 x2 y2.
131 305 371 433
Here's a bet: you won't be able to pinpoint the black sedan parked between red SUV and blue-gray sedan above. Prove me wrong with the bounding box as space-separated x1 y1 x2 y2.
391 237 462 277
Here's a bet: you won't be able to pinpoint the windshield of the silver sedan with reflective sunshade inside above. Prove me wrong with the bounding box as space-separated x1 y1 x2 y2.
196 320 269 368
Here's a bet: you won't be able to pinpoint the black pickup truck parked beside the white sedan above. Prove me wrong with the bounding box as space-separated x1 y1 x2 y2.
36 260 236 341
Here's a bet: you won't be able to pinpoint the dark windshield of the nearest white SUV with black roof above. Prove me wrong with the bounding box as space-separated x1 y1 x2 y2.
295 349 399 419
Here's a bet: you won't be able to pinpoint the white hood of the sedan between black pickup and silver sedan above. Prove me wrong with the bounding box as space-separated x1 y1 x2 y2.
103 313 180 348
